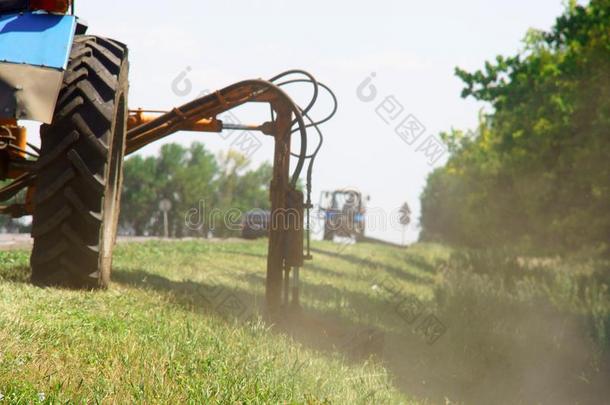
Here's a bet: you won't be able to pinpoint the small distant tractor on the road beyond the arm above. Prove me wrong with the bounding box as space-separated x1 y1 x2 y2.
320 189 370 241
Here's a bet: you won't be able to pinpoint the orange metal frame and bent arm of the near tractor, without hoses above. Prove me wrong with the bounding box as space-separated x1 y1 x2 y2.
0 80 306 316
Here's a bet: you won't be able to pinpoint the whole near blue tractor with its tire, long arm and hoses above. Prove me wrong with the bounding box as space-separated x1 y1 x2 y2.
0 0 336 311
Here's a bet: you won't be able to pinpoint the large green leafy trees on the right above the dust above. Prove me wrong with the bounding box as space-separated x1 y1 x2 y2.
421 0 610 253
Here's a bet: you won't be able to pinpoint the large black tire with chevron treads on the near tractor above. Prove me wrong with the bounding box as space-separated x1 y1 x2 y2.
30 35 129 289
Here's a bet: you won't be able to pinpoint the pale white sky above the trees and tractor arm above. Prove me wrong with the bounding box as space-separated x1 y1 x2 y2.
29 0 576 242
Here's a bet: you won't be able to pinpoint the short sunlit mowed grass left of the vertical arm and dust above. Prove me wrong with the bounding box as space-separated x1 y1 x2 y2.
0 241 414 404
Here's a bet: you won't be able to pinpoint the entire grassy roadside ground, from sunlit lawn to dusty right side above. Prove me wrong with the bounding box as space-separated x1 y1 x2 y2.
0 241 610 404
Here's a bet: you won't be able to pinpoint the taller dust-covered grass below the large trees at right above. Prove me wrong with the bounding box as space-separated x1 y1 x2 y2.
434 251 610 404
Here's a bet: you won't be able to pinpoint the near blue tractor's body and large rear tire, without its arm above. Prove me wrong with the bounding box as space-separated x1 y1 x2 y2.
0 0 129 287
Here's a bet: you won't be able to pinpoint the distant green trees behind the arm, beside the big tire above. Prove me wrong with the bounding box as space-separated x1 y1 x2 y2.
119 142 272 237
